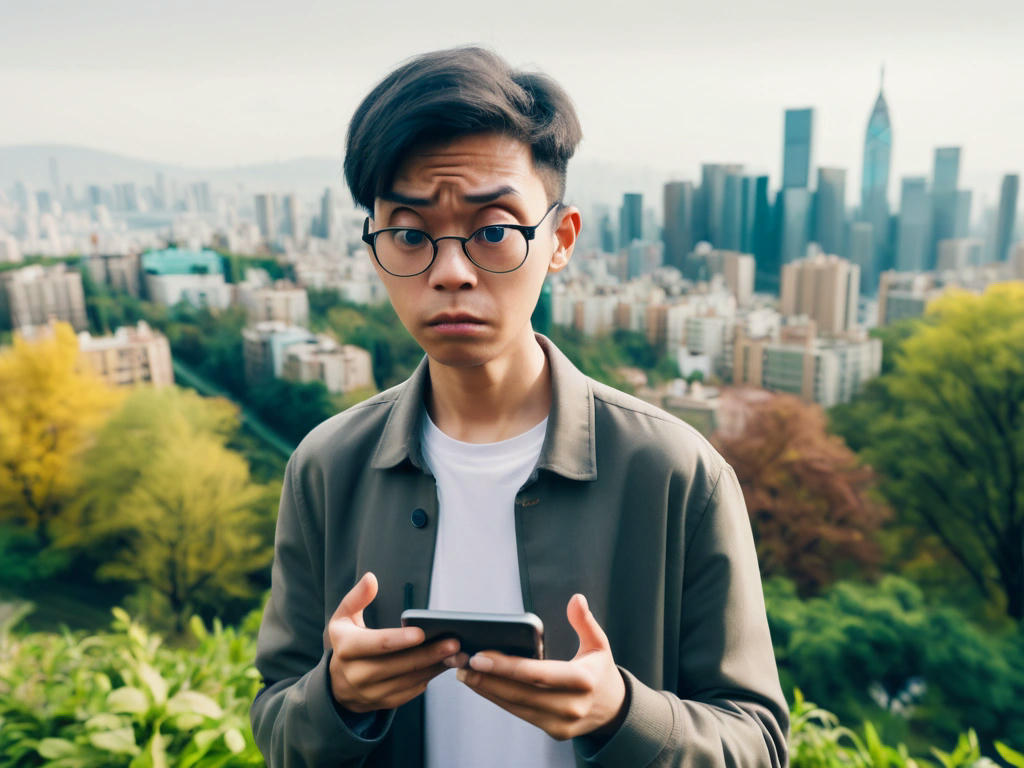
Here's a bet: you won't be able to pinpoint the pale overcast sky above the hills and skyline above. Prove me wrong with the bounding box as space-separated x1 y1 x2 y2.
0 0 1024 204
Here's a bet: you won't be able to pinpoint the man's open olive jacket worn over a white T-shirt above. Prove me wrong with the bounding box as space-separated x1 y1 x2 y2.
251 335 790 768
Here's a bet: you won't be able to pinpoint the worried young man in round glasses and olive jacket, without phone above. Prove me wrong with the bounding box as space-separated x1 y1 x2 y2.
252 48 788 768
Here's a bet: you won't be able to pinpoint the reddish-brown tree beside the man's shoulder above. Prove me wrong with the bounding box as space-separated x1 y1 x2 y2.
712 393 886 595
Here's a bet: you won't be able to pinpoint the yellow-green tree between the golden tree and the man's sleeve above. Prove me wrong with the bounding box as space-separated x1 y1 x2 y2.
60 388 272 632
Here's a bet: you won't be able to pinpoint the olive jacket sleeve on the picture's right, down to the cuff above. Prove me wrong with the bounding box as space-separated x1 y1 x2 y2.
575 462 790 768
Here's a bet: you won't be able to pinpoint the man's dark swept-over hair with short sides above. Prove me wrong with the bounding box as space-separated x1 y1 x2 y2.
345 47 583 213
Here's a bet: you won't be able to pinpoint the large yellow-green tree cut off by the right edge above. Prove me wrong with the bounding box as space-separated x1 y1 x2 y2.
847 282 1024 621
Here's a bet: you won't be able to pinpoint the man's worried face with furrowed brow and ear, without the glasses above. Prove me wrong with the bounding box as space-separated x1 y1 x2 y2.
368 134 580 368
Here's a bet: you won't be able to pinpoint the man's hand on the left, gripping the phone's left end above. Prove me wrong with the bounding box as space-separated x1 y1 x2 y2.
328 571 459 712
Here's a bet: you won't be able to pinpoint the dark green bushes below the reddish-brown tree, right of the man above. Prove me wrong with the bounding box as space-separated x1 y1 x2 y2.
765 575 1024 743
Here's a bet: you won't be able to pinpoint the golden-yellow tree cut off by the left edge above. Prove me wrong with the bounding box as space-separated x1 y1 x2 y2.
0 323 120 545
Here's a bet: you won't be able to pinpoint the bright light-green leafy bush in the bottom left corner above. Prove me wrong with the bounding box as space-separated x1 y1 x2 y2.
0 608 263 768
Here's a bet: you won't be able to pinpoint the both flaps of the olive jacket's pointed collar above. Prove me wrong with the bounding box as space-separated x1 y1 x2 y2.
372 334 597 480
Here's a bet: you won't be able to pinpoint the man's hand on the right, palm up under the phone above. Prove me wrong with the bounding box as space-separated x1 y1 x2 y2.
458 595 626 740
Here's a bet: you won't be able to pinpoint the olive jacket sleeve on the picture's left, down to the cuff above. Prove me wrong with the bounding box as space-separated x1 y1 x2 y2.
250 456 394 768
